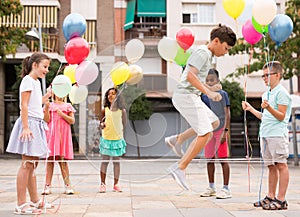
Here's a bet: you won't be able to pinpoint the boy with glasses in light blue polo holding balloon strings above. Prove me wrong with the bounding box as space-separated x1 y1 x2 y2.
242 61 291 210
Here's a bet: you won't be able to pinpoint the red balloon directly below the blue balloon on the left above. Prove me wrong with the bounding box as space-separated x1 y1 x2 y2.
65 37 90 64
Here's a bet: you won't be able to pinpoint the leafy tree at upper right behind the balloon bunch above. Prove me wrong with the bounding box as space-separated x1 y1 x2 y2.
229 0 300 79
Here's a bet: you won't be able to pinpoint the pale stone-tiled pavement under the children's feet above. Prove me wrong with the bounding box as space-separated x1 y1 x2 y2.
0 159 300 217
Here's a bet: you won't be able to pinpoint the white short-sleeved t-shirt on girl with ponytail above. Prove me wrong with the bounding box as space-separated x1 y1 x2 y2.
19 75 44 119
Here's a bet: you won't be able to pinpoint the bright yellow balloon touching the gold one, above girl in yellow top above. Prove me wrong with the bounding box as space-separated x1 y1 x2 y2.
110 61 130 85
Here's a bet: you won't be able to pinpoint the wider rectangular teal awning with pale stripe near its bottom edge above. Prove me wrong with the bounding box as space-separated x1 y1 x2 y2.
137 0 166 17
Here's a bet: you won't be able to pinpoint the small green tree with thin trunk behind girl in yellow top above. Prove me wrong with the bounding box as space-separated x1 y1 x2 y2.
123 86 153 157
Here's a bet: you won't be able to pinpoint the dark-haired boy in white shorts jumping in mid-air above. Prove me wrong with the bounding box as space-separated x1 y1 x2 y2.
166 24 236 190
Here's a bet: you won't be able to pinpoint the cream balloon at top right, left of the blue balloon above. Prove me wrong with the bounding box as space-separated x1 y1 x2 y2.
252 0 277 26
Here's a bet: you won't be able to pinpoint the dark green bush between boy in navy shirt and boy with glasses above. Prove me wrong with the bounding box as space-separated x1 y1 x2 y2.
221 80 245 117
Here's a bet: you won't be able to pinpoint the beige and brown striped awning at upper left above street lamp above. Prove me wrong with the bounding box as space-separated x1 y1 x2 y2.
0 5 58 28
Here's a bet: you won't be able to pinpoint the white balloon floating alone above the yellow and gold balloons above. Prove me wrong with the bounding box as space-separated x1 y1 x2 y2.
125 39 145 63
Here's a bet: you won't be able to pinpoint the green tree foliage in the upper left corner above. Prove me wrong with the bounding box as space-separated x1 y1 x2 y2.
0 0 26 61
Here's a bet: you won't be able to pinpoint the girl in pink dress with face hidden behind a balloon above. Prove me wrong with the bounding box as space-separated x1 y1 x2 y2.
42 95 75 195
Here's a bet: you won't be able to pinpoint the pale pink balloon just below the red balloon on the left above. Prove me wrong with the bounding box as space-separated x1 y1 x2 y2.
75 61 99 85
